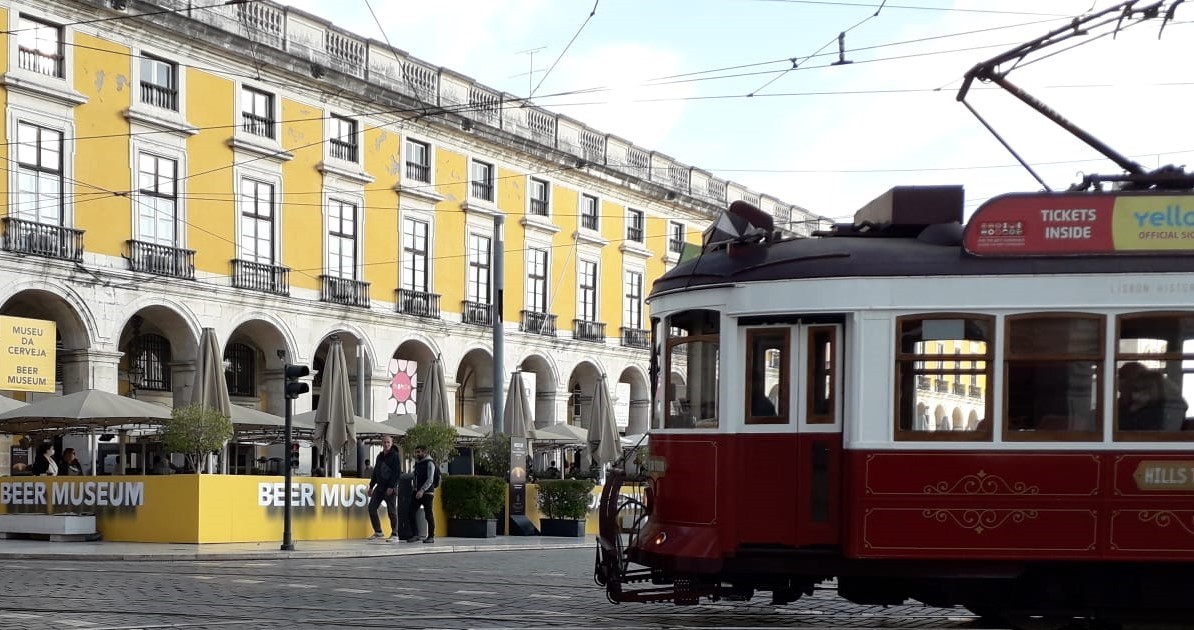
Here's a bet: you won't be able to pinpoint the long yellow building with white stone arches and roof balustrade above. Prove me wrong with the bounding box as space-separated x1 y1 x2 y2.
0 0 811 471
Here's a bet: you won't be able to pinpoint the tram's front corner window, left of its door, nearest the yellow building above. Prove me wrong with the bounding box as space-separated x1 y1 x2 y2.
663 310 720 428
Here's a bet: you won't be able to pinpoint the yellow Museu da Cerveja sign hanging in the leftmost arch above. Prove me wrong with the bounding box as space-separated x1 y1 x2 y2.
0 315 57 391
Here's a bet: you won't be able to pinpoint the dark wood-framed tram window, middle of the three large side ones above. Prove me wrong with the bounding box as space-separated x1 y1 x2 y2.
1004 314 1103 440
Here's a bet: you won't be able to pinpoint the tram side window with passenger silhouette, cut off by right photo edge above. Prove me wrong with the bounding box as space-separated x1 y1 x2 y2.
1114 313 1194 440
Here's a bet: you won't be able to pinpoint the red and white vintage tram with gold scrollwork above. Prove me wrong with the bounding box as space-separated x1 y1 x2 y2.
597 186 1194 625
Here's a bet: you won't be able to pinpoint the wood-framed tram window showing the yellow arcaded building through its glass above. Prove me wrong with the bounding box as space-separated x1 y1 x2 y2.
896 314 995 440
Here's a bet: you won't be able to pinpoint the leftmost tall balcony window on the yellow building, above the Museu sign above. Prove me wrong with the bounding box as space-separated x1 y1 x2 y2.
16 122 66 226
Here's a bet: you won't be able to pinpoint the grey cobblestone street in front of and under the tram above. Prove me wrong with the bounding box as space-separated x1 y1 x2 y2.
0 543 1108 630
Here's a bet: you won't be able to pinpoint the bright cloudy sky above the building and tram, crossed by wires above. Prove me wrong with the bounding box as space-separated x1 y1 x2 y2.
277 0 1194 220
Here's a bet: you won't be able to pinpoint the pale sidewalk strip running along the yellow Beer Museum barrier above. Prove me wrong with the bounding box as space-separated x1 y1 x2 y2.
0 536 596 561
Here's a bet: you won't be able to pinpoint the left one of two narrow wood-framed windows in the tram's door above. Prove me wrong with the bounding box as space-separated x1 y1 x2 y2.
744 328 788 425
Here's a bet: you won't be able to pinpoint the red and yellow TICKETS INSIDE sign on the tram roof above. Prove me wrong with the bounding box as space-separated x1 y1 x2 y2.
964 193 1194 257
